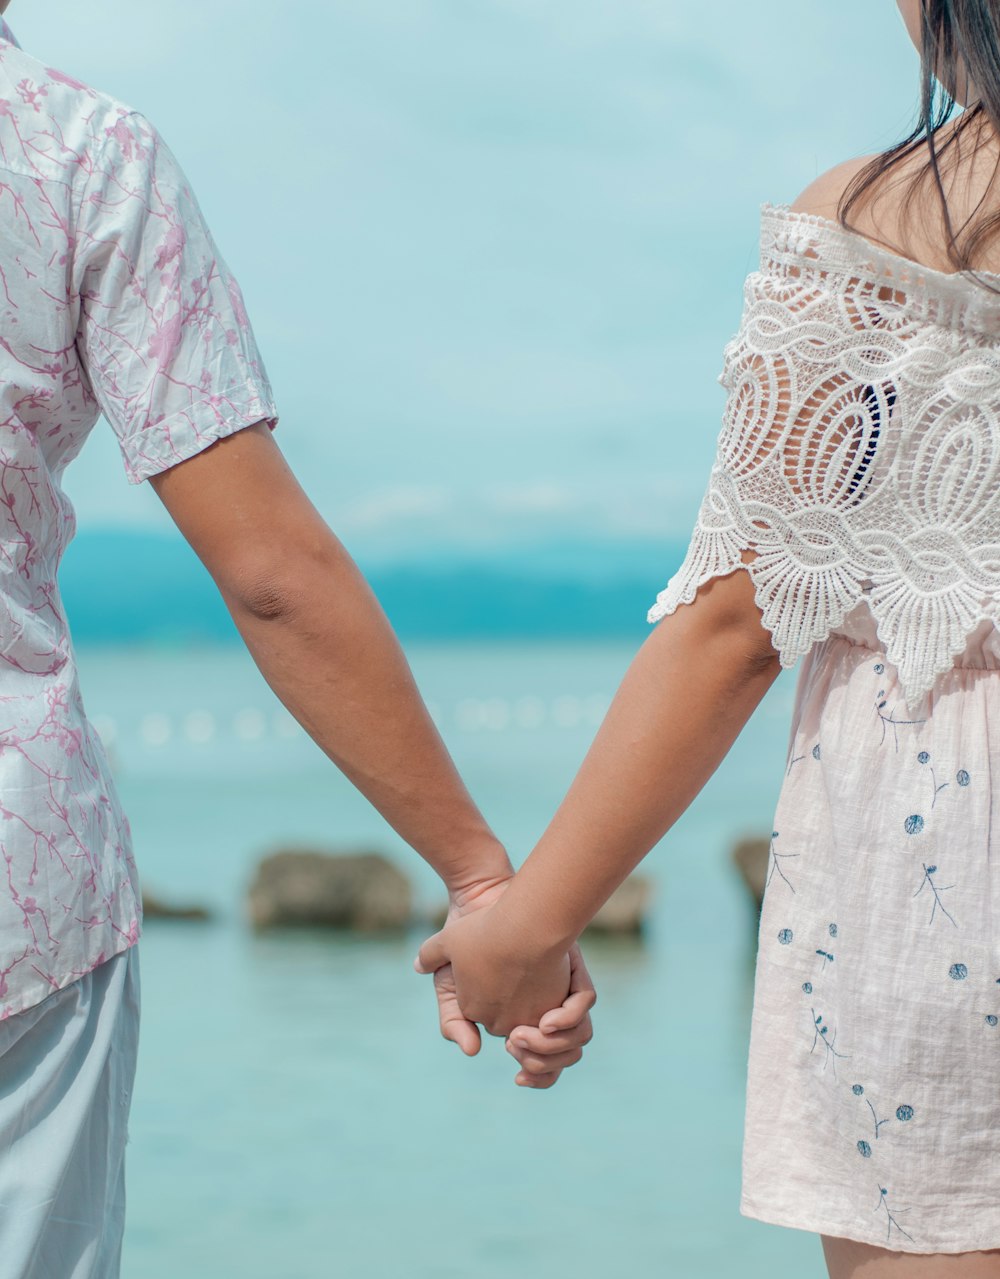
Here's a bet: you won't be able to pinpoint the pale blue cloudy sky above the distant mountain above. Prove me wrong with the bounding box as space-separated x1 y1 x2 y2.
9 0 916 560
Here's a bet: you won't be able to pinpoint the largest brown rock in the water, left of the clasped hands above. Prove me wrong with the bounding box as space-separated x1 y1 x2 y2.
248 849 413 932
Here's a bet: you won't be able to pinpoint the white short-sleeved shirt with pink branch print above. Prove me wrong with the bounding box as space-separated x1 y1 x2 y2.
0 22 275 1018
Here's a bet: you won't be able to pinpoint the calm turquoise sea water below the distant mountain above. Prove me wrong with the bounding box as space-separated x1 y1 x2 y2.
74 643 822 1279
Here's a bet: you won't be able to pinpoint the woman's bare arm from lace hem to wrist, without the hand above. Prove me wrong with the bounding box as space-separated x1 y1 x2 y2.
501 572 780 949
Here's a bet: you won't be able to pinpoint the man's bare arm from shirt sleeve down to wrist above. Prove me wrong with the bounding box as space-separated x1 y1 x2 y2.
151 425 516 900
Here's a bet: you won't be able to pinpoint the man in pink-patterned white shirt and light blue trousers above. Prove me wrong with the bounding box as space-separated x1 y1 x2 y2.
0 9 593 1279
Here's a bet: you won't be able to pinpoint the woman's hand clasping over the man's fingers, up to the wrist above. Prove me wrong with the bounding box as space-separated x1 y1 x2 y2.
416 906 572 1037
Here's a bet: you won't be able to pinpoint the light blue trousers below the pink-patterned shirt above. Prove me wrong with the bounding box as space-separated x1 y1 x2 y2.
0 946 139 1279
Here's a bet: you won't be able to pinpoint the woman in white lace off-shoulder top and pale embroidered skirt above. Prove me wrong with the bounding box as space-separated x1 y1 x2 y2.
418 0 1000 1279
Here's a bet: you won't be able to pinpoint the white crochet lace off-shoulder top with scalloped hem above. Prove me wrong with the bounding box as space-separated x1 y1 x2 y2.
650 206 1000 703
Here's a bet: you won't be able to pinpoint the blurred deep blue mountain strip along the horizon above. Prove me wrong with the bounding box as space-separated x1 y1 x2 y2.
60 531 684 645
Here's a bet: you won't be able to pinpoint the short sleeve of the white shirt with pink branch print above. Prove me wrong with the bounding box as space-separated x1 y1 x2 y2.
73 113 276 483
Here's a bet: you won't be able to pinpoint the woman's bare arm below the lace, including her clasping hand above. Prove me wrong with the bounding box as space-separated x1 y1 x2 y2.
418 572 780 1033
